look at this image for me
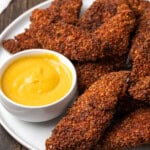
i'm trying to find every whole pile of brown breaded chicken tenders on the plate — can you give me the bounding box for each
[3,0,150,150]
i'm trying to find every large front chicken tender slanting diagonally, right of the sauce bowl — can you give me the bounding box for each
[46,71,129,150]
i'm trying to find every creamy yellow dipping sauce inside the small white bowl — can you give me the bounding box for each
[2,54,72,106]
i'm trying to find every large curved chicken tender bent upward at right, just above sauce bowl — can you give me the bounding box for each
[36,5,135,62]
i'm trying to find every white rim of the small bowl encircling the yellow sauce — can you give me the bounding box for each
[0,48,77,109]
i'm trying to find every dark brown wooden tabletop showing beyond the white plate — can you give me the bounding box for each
[0,0,44,150]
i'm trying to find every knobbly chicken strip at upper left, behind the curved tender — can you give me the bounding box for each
[3,0,82,53]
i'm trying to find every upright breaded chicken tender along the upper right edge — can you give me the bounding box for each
[130,9,150,80]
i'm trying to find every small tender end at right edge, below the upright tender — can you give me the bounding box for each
[129,76,150,104]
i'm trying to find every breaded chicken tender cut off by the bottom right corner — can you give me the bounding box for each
[95,108,150,150]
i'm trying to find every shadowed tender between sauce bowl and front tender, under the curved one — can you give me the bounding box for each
[74,55,126,94]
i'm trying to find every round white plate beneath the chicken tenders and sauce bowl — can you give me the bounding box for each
[0,0,150,150]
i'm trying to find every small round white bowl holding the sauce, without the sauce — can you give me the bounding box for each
[0,49,77,122]
